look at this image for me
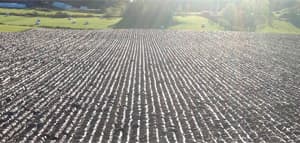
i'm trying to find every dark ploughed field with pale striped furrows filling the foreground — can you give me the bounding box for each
[0,29,300,143]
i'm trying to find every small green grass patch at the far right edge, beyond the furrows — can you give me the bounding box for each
[257,20,300,34]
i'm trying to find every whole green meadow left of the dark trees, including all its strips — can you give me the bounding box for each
[0,8,120,32]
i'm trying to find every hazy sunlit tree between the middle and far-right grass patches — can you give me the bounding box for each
[221,0,272,31]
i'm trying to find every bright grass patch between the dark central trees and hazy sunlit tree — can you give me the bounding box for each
[170,16,224,31]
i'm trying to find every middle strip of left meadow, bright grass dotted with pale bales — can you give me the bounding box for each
[0,15,120,29]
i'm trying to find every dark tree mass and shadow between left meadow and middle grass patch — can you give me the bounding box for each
[113,0,175,29]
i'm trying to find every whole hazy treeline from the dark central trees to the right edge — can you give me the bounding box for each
[112,0,300,31]
